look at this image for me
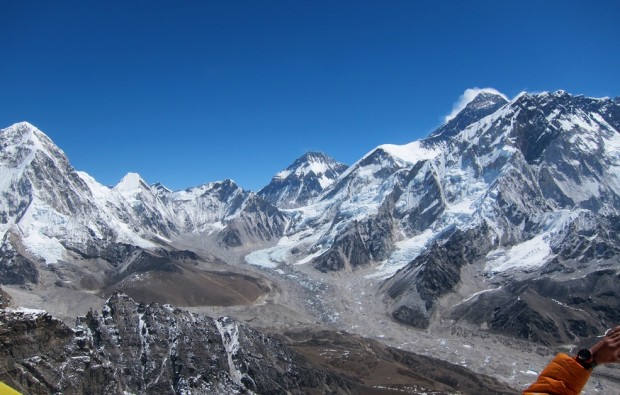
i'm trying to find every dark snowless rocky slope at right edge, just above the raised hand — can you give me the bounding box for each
[452,270,620,345]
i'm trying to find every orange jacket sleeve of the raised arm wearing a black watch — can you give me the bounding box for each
[523,354,590,395]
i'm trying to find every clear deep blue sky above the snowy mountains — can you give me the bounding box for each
[0,0,620,190]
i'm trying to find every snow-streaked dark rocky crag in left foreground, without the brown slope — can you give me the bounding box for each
[0,294,355,394]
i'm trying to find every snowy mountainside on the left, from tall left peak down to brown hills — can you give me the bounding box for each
[0,123,288,284]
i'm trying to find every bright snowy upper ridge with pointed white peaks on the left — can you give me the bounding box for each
[0,123,272,264]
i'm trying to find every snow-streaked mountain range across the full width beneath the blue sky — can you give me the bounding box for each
[0,91,620,395]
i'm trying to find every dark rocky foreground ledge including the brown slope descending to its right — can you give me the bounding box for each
[0,293,516,394]
